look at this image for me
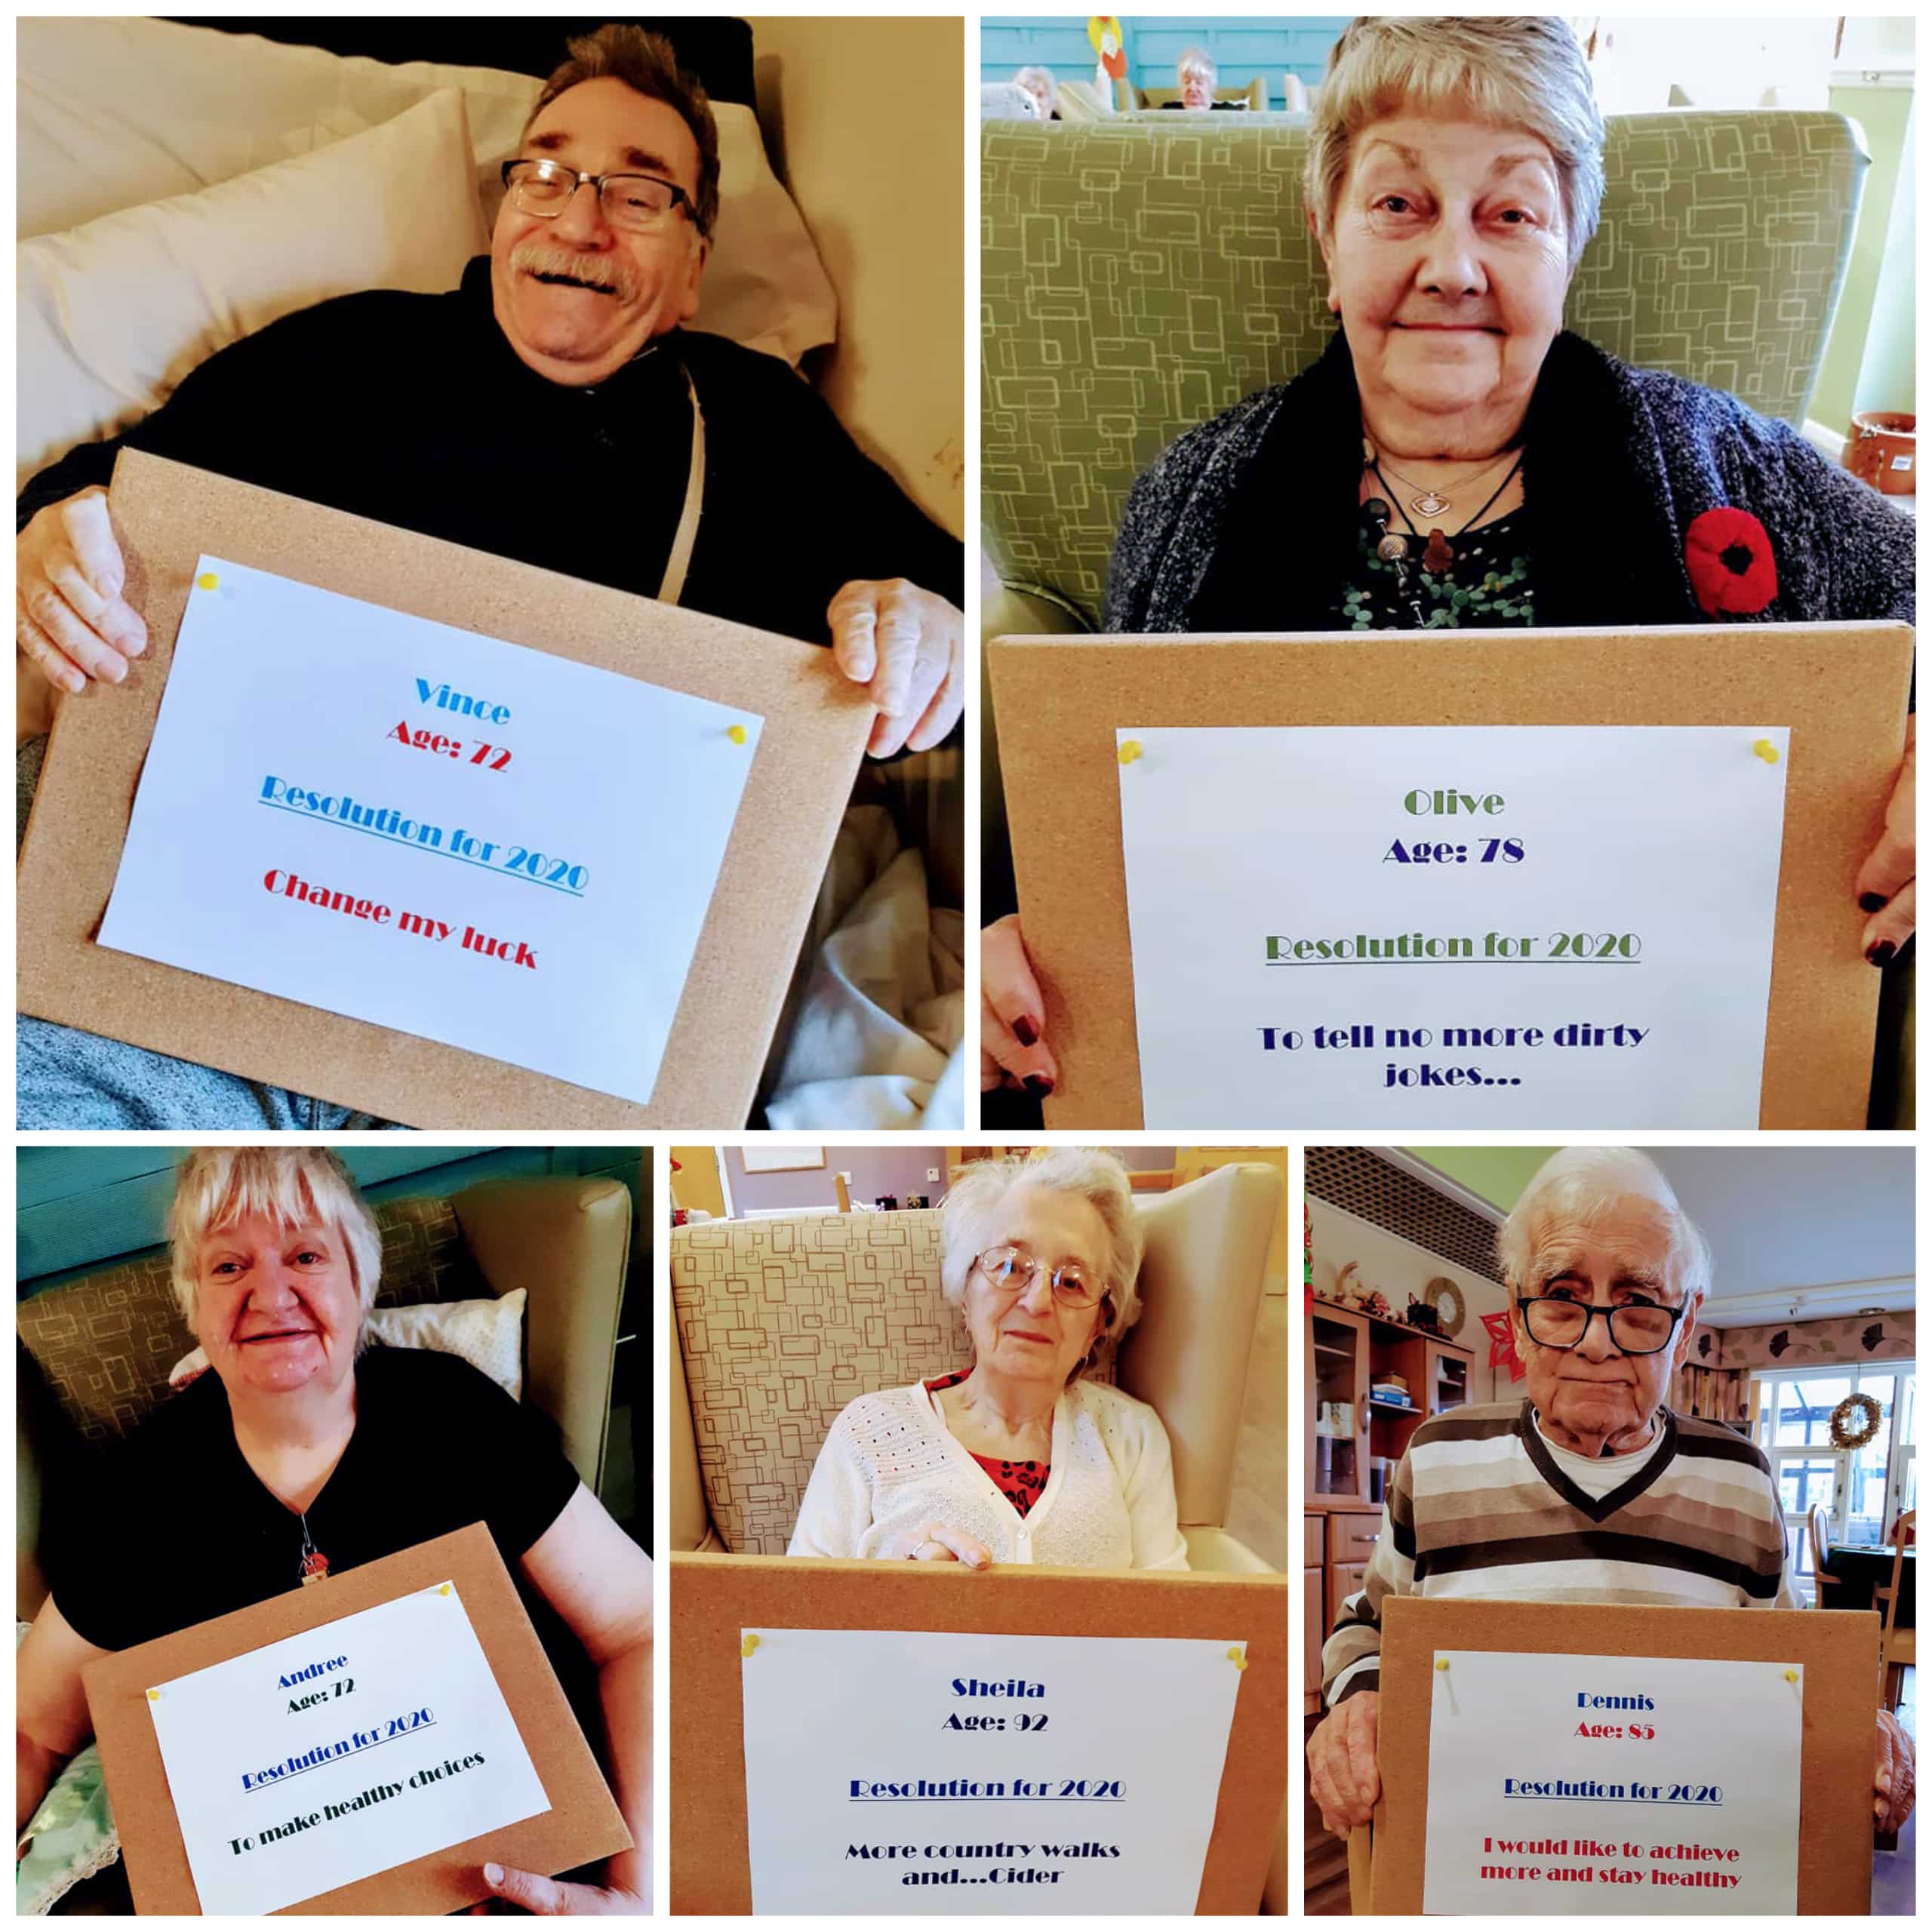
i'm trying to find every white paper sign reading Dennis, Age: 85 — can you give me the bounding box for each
[1422,1650,1804,1918]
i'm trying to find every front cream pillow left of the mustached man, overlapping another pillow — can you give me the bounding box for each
[14,89,487,489]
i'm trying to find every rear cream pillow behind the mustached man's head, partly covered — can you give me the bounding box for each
[15,20,838,369]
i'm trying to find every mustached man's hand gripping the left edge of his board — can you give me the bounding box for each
[14,489,147,726]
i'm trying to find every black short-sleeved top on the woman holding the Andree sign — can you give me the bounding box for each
[41,1349,582,1654]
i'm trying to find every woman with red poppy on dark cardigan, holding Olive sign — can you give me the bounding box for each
[980,14,1918,1096]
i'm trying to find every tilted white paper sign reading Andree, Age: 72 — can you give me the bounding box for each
[149,1584,551,1912]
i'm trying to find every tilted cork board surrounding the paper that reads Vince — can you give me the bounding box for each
[17,450,873,1128]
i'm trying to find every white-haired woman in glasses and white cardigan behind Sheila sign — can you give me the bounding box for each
[788,1148,1188,1571]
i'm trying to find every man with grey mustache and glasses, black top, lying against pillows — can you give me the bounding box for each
[15,27,966,1126]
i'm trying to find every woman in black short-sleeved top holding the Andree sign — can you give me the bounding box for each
[15,1148,651,1912]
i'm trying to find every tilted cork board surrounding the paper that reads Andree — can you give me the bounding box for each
[82,1522,632,1917]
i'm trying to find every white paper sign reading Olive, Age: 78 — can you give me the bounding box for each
[1118,724,1792,1131]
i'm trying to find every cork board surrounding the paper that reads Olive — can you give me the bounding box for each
[987,622,1912,1131]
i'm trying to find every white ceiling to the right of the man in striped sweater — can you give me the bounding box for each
[1644,1146,1917,1327]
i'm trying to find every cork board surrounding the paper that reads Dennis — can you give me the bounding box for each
[1367,1596,1878,1918]
